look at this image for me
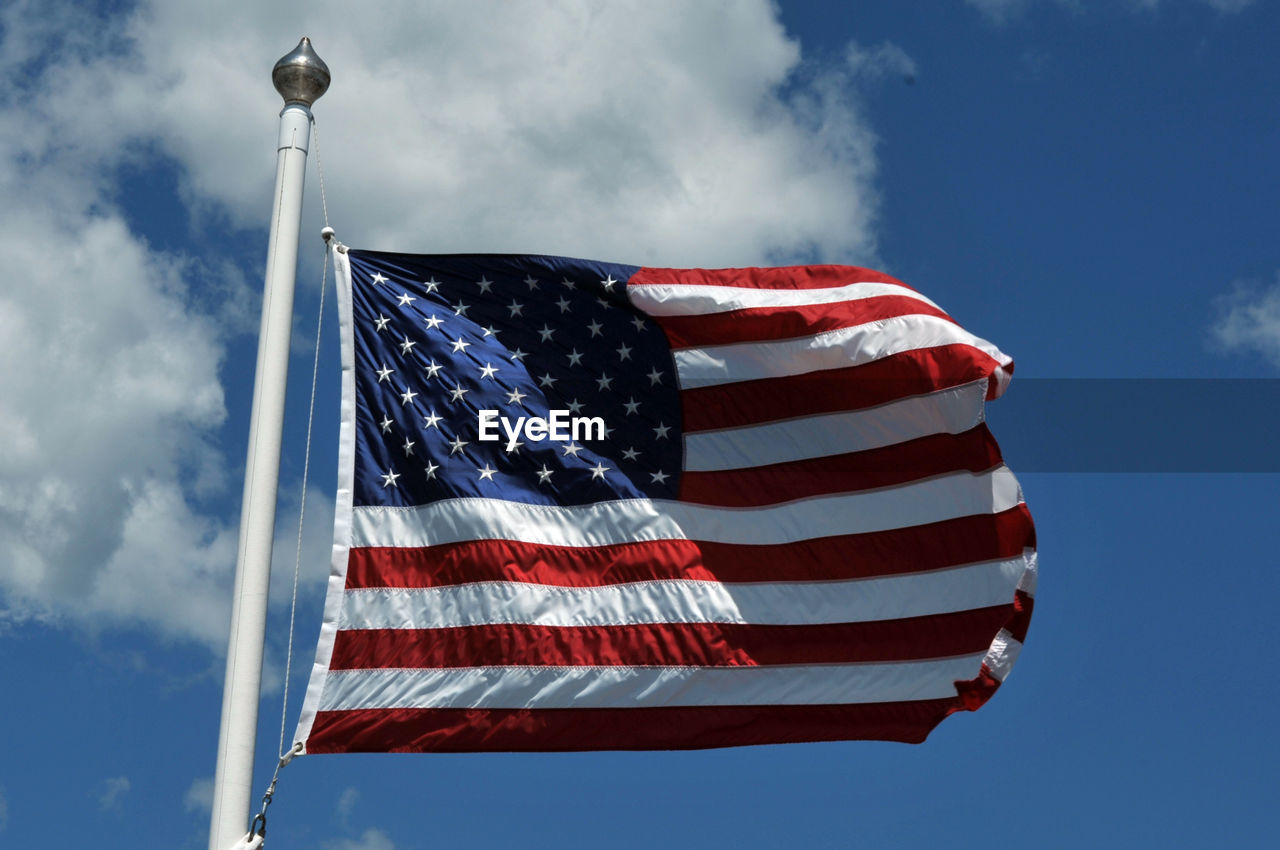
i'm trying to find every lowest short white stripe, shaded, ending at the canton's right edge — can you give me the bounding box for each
[685,379,987,472]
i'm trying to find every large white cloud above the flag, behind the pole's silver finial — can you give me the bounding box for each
[67,0,874,264]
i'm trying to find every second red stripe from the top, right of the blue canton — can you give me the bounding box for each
[654,296,955,348]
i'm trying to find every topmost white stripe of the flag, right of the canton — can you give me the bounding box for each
[627,283,941,316]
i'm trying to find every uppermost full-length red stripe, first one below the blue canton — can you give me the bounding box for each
[347,504,1034,589]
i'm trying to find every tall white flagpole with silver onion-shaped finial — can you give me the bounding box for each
[209,38,329,850]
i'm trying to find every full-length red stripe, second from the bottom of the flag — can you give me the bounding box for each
[329,604,1014,670]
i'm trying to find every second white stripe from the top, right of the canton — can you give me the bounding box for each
[672,315,1010,389]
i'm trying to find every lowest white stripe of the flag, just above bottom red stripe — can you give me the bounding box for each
[314,655,982,712]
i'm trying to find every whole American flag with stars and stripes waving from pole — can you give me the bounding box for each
[296,248,1036,753]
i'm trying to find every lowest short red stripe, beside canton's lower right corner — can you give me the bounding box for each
[680,425,1002,507]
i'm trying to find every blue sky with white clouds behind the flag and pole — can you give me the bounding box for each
[0,0,1280,850]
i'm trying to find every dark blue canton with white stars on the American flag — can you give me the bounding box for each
[348,251,682,506]
